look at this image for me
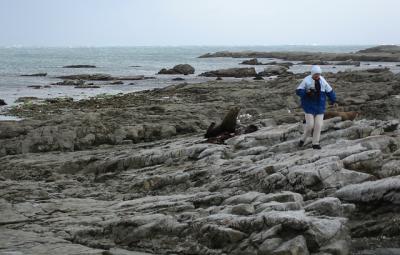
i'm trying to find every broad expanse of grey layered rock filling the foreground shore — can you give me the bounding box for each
[0,46,400,255]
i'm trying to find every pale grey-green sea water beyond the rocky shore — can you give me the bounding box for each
[0,45,396,105]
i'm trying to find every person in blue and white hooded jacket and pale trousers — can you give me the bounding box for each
[296,65,336,150]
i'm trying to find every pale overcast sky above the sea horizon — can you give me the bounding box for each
[0,0,400,46]
